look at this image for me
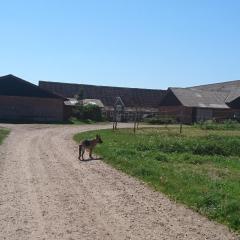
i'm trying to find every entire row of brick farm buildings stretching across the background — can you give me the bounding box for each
[0,75,240,124]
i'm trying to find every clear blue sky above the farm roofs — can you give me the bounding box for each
[0,0,240,89]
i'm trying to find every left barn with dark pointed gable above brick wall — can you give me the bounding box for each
[0,75,66,122]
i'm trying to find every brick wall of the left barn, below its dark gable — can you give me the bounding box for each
[0,96,64,122]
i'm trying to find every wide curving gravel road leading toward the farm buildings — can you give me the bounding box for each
[0,125,237,240]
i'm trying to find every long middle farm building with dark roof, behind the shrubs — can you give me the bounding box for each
[39,81,166,121]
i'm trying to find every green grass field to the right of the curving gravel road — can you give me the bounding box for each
[74,127,240,232]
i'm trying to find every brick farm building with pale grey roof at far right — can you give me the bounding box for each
[159,81,240,123]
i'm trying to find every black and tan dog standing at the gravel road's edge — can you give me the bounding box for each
[78,135,103,160]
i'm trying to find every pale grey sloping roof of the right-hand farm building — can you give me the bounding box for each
[170,88,229,108]
